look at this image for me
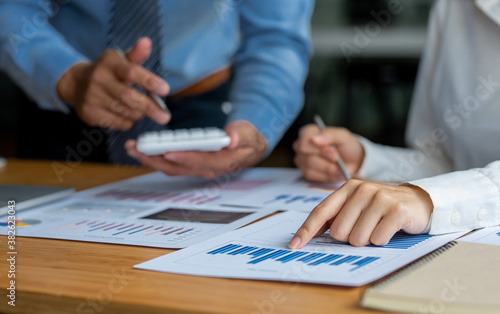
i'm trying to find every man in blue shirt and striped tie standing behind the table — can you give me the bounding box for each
[0,0,314,177]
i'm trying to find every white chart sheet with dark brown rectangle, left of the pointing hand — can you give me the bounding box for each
[0,202,272,249]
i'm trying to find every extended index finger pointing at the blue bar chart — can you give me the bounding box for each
[288,188,347,249]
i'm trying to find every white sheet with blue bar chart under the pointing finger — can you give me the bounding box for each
[135,211,463,286]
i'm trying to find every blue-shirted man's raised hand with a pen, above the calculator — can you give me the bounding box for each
[56,38,170,130]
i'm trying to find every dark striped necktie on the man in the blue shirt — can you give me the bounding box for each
[107,0,162,164]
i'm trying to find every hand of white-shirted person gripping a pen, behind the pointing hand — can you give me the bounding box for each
[293,124,365,183]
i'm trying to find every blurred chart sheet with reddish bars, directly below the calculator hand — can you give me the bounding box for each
[74,168,300,207]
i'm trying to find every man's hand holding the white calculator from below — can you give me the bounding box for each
[125,121,267,178]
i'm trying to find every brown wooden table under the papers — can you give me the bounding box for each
[0,159,379,314]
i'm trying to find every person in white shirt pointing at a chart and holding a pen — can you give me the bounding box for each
[289,0,500,248]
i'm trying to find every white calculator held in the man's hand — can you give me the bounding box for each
[137,127,231,156]
